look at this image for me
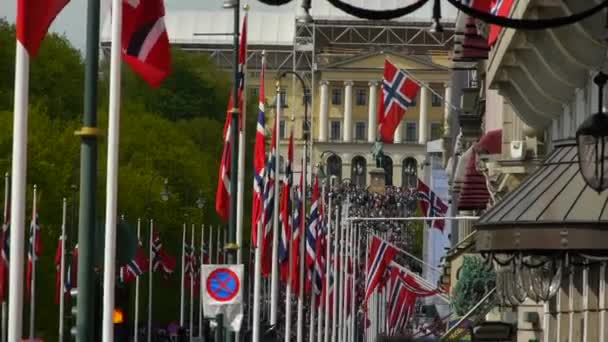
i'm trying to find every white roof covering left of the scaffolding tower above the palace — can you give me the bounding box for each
[101,11,295,46]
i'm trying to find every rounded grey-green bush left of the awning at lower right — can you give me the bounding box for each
[452,255,496,316]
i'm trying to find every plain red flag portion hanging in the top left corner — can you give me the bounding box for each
[17,0,70,57]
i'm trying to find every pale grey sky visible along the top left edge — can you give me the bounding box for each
[0,0,288,49]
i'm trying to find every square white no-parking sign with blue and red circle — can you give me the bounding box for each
[201,264,245,331]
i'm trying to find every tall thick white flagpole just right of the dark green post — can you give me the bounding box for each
[102,0,122,342]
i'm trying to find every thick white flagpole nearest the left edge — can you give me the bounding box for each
[8,26,30,342]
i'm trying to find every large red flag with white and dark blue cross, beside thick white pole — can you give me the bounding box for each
[122,0,171,88]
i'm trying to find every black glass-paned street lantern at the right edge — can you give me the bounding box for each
[576,71,608,193]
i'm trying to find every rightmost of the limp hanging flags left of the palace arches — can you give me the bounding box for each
[306,177,321,294]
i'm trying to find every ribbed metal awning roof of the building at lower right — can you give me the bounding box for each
[475,140,608,251]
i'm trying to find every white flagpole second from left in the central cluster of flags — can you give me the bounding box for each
[270,81,283,326]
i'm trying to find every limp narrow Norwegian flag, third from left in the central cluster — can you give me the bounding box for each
[279,131,293,282]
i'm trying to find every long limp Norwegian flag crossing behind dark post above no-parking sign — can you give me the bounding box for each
[215,15,247,222]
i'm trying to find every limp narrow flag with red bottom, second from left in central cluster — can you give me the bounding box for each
[262,122,277,277]
